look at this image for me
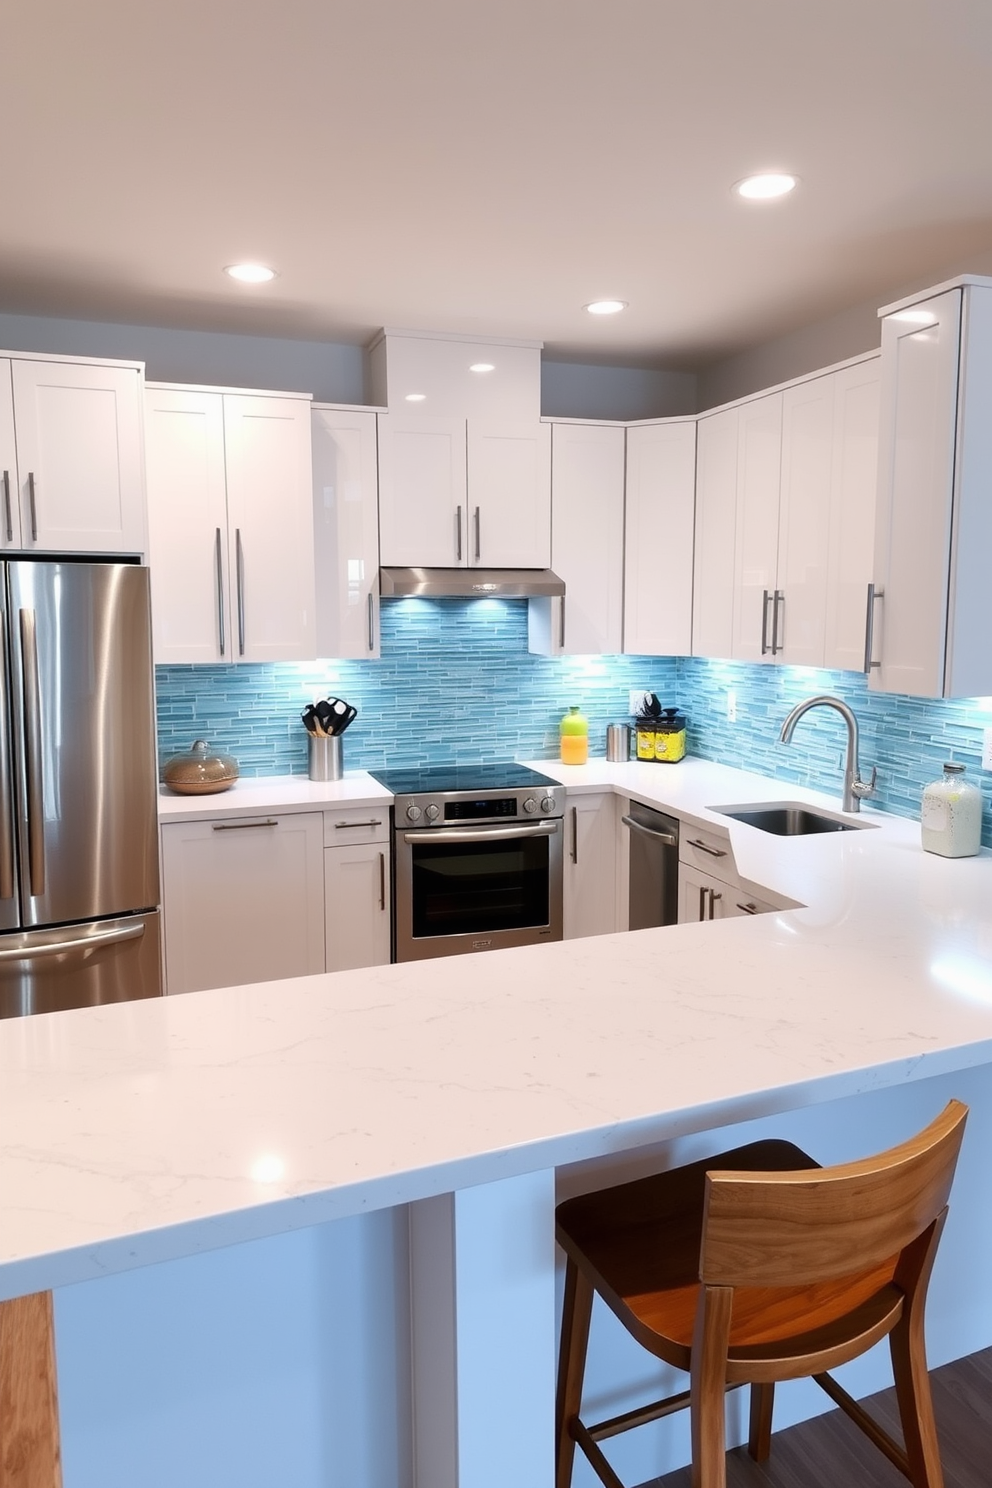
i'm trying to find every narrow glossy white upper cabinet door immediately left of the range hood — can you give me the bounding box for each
[312,406,379,661]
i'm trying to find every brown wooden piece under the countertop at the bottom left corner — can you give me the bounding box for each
[0,1292,62,1488]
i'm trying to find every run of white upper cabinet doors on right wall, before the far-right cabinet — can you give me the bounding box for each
[693,357,879,671]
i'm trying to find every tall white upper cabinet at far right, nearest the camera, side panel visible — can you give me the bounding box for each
[870,281,992,698]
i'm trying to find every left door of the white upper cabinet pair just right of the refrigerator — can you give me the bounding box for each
[144,387,233,664]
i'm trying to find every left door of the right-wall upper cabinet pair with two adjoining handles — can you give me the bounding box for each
[733,393,782,662]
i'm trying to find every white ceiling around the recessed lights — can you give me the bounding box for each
[0,0,992,368]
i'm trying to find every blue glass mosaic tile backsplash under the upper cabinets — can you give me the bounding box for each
[156,600,992,847]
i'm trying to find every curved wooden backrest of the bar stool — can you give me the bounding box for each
[699,1101,968,1287]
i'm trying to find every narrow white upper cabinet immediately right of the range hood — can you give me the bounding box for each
[528,424,623,656]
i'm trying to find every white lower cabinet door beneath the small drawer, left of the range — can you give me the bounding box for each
[324,842,390,972]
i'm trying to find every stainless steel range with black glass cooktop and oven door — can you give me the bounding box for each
[372,765,565,961]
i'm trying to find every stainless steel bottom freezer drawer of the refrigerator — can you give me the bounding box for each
[0,909,162,1018]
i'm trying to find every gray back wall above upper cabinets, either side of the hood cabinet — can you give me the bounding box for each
[0,314,696,418]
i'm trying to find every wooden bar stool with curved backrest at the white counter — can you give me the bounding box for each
[556,1101,968,1488]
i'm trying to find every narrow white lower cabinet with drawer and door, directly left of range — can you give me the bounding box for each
[324,806,390,972]
